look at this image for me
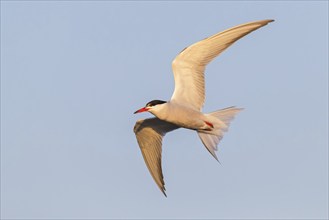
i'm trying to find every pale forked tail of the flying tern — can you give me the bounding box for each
[197,107,243,161]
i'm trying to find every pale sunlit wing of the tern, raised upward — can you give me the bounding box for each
[171,20,273,111]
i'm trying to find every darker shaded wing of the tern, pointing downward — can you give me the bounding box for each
[134,118,179,196]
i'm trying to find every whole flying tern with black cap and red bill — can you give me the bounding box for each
[134,20,274,196]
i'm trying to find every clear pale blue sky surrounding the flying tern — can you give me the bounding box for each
[1,1,328,219]
